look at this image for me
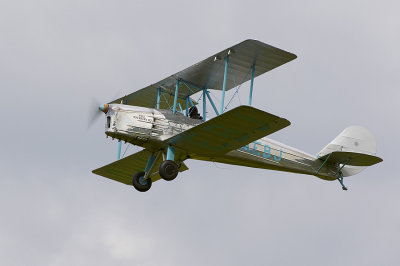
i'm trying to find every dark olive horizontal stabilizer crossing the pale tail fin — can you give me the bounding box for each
[319,151,382,166]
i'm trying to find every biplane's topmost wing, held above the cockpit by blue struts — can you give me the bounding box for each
[111,40,296,109]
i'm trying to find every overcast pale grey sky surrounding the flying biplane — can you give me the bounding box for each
[0,0,400,266]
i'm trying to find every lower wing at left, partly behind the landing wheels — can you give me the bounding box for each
[92,150,188,185]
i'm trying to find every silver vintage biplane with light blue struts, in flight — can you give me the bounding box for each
[93,40,382,192]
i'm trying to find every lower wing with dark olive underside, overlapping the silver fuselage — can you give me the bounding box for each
[166,106,290,156]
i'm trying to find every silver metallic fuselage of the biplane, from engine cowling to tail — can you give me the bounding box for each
[105,104,338,180]
